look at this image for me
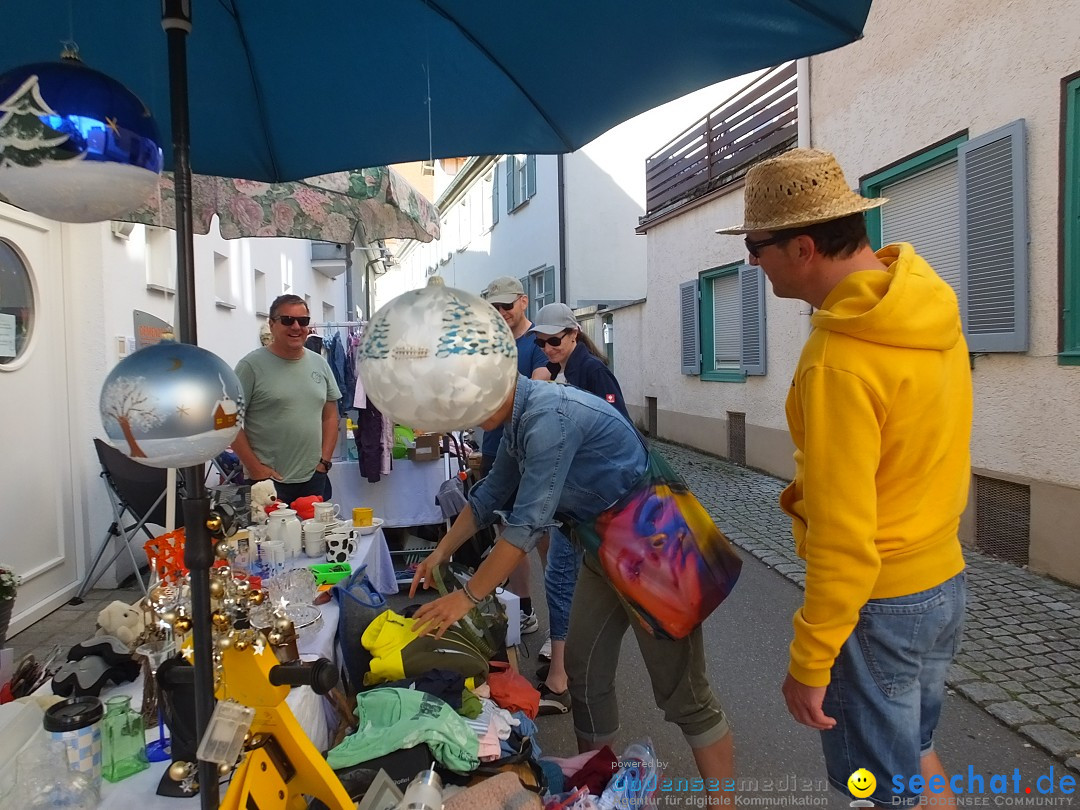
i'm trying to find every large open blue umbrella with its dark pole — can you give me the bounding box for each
[0,0,870,808]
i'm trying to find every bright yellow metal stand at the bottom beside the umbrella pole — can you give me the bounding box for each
[217,645,356,810]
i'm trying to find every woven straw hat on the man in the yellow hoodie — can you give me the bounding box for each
[716,149,889,233]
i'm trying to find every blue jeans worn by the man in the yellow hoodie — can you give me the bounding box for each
[821,572,966,807]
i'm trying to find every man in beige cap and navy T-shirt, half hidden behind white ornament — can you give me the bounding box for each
[480,275,551,633]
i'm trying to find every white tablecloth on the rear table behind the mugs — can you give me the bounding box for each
[329,456,450,527]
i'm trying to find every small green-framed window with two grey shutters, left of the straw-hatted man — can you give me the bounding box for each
[679,265,766,382]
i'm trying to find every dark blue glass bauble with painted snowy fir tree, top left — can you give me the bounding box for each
[0,49,163,222]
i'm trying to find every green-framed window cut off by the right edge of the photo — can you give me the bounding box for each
[1057,76,1080,366]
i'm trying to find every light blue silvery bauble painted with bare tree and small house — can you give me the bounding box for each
[100,340,243,467]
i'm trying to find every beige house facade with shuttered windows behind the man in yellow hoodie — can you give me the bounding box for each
[615,0,1080,583]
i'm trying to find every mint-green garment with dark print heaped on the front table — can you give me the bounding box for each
[326,687,480,773]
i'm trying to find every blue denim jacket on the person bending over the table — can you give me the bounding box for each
[469,376,648,552]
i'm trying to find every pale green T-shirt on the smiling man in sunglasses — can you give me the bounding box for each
[237,348,341,484]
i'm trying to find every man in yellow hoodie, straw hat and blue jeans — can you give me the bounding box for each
[718,149,972,806]
